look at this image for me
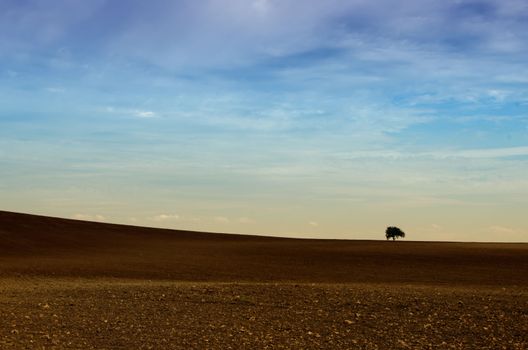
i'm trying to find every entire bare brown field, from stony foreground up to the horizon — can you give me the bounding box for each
[0,211,528,349]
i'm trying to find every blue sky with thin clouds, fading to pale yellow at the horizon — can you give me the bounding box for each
[0,0,528,242]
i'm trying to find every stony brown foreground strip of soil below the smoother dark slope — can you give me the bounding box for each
[0,278,528,349]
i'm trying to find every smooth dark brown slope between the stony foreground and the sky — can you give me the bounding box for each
[0,211,528,286]
